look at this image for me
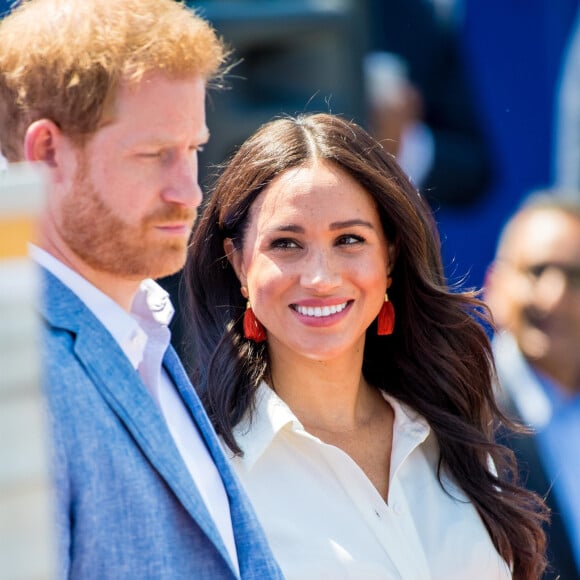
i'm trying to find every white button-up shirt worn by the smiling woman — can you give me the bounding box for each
[232,383,511,580]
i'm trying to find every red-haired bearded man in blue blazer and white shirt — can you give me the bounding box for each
[0,0,280,580]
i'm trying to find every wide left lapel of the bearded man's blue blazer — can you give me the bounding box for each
[41,273,231,566]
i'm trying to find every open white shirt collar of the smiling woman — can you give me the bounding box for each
[233,382,430,473]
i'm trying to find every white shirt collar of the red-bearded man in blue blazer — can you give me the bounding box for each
[29,244,174,369]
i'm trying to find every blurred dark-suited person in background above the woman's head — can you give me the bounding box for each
[364,0,493,209]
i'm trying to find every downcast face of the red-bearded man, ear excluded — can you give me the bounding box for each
[51,74,208,280]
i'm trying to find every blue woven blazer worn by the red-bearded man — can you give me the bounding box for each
[41,269,282,580]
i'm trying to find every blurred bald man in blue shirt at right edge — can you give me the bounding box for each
[486,195,580,580]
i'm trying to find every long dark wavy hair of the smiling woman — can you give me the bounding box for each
[183,113,546,580]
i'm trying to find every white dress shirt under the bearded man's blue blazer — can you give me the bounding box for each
[29,245,239,571]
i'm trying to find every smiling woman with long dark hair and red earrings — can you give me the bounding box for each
[185,114,544,580]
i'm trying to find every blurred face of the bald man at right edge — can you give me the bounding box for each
[487,209,580,376]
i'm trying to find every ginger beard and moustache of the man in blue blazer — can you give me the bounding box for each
[62,155,196,280]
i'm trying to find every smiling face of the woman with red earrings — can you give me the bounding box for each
[226,162,392,360]
